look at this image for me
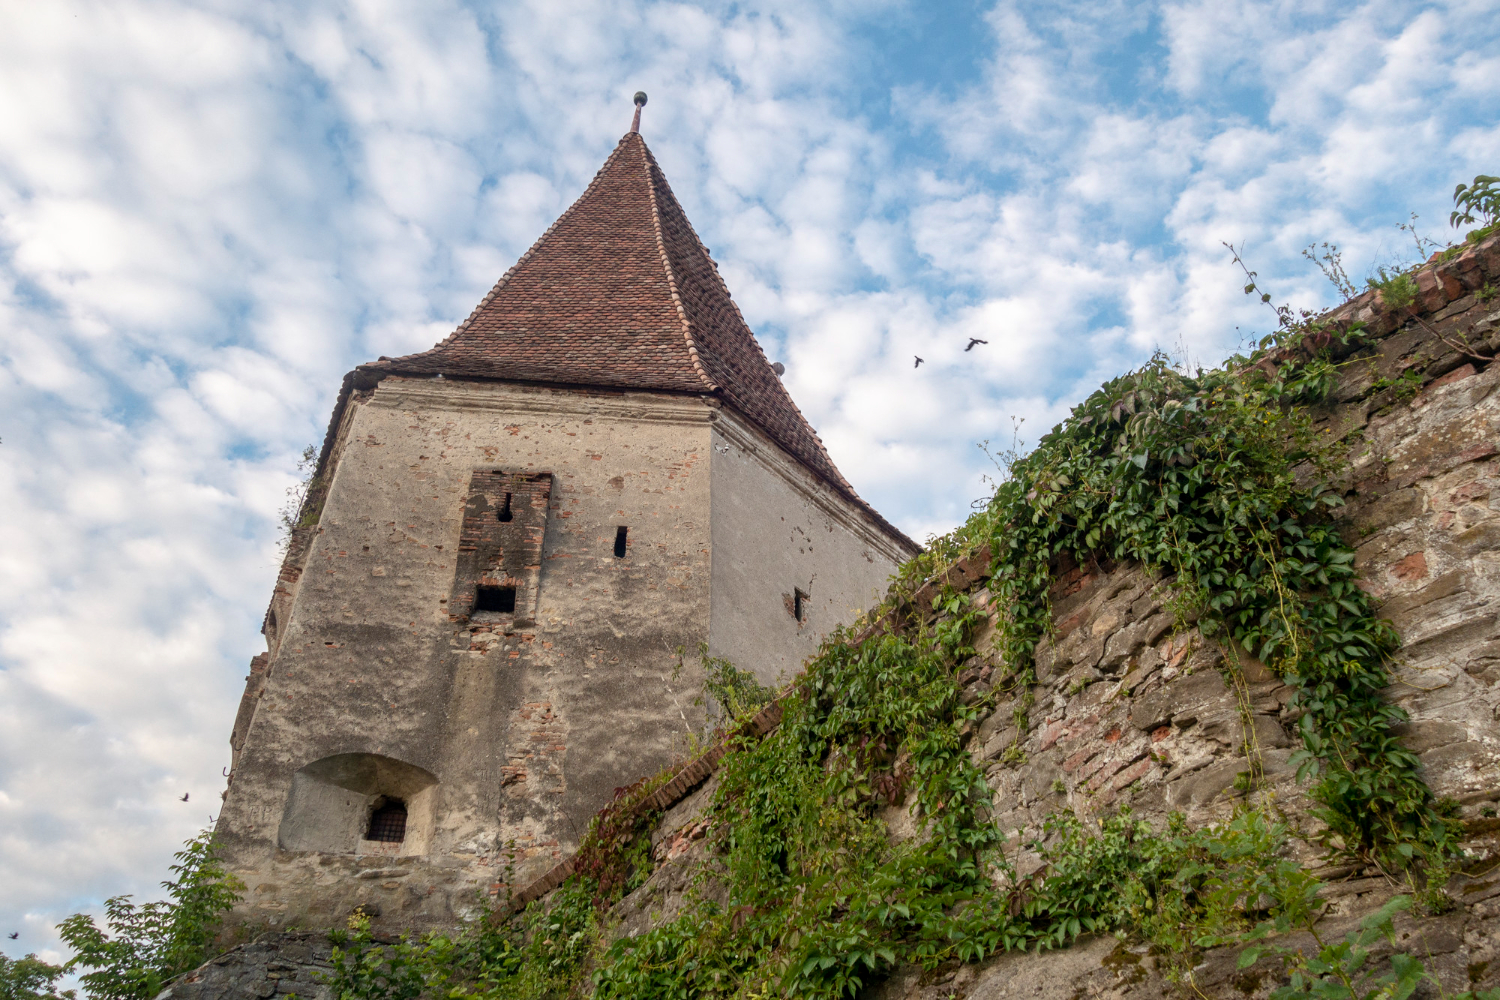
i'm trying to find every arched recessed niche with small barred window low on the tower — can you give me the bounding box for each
[276,754,438,855]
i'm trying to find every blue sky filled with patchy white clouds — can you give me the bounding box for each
[0,0,1500,957]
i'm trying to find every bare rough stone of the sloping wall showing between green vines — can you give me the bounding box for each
[185,238,1500,1000]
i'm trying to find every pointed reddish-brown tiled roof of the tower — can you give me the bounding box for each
[360,132,911,544]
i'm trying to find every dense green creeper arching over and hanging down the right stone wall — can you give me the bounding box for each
[969,331,1451,867]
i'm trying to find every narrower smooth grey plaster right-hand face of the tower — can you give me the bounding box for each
[708,411,915,684]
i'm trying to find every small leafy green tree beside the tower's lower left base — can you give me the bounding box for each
[57,831,245,1000]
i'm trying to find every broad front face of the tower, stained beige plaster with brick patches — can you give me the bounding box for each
[219,378,720,928]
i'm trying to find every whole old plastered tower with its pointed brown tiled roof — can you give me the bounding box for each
[218,121,918,928]
